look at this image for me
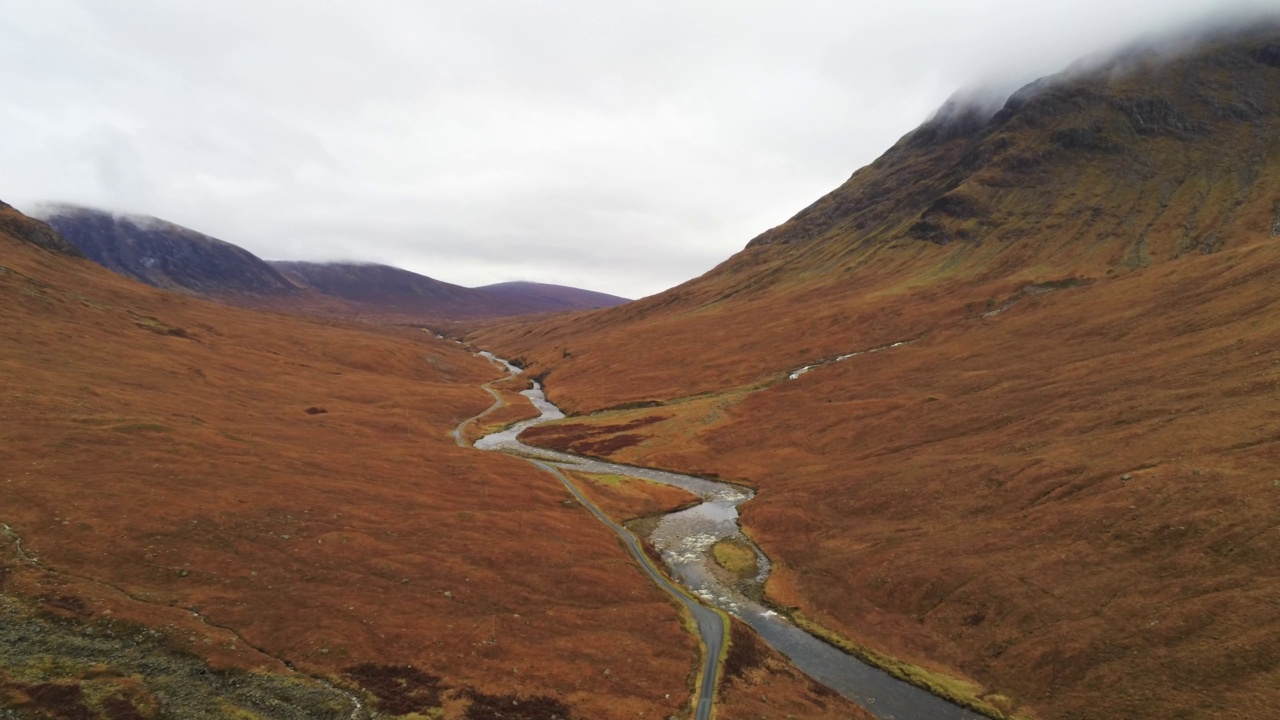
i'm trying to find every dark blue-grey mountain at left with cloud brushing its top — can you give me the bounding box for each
[37,205,297,296]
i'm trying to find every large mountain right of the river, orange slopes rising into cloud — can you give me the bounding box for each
[467,20,1280,720]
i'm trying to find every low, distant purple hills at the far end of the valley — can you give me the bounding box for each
[271,261,627,318]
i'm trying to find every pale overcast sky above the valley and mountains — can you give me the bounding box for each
[0,0,1280,297]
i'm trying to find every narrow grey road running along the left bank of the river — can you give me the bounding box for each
[451,356,728,720]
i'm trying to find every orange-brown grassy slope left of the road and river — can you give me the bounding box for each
[0,210,698,719]
